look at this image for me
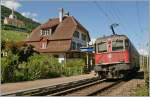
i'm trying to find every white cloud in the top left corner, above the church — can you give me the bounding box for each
[1,0,22,10]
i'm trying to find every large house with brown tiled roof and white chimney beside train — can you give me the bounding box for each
[26,9,90,63]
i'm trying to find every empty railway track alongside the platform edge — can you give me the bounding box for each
[1,77,102,96]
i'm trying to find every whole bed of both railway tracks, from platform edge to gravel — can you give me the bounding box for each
[1,71,139,96]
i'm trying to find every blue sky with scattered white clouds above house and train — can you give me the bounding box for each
[2,0,149,54]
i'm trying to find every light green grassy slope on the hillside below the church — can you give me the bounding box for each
[1,30,28,42]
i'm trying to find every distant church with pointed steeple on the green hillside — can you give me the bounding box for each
[4,9,25,27]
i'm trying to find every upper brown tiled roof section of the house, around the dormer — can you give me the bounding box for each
[27,16,90,41]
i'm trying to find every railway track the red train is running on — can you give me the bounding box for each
[52,80,122,96]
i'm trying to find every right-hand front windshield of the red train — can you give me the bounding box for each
[112,40,124,51]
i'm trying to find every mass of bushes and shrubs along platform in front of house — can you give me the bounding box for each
[1,41,85,82]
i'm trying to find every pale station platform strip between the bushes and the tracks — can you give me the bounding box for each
[1,73,95,94]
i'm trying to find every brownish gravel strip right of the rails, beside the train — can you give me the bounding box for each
[98,72,144,96]
